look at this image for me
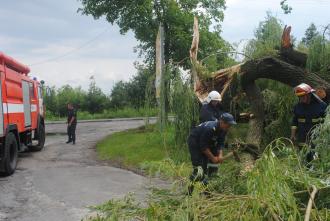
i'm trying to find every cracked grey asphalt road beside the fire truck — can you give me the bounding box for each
[0,120,156,221]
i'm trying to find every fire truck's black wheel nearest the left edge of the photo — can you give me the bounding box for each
[2,132,18,176]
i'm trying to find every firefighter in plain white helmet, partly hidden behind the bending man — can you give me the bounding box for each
[199,91,224,123]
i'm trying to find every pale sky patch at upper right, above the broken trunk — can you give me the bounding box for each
[222,0,330,42]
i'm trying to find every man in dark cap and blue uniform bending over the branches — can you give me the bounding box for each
[188,113,236,194]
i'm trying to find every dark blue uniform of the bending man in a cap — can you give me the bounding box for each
[188,121,227,181]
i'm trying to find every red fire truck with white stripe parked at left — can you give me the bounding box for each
[0,52,45,175]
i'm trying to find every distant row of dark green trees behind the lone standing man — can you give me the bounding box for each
[44,66,156,116]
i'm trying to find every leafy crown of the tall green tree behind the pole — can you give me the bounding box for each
[80,0,229,67]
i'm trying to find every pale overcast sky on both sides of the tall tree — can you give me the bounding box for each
[0,0,330,93]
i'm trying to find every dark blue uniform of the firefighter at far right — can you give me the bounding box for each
[292,96,327,145]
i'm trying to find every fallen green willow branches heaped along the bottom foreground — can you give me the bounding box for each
[87,140,329,221]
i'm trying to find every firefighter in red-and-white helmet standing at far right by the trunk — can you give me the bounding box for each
[291,83,327,162]
